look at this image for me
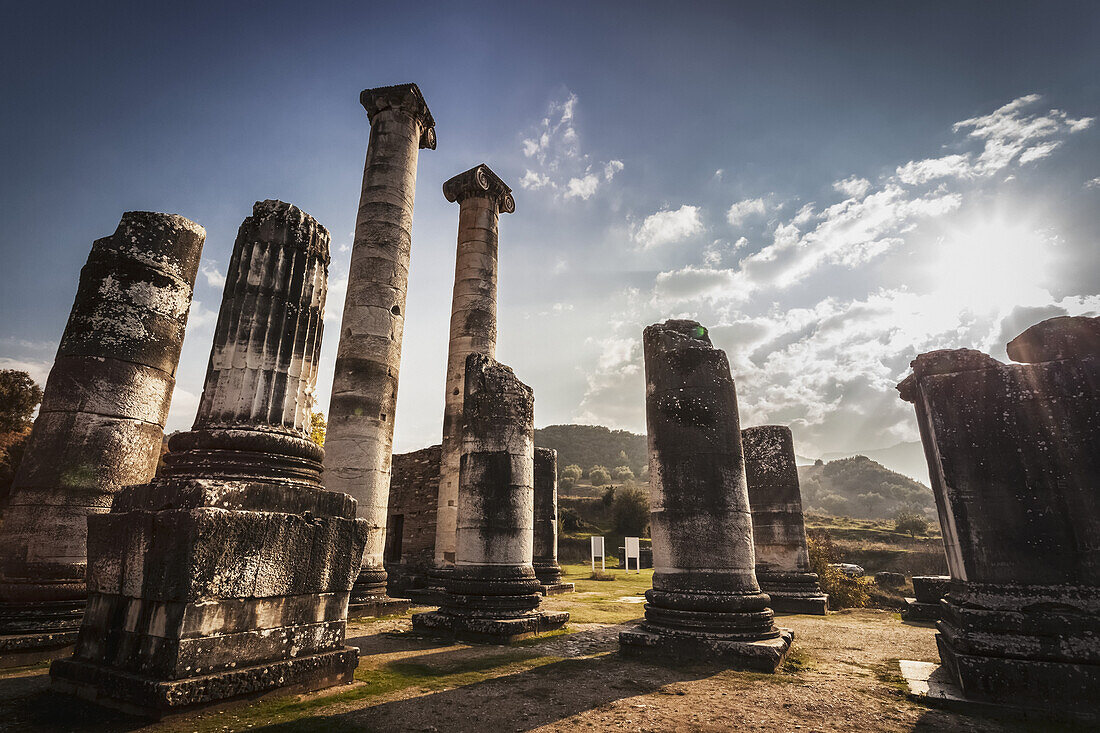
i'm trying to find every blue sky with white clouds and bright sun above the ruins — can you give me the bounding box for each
[0,2,1100,456]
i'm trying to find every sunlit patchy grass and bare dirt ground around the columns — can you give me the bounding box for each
[0,565,1062,733]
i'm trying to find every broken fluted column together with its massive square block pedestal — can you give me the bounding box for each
[51,200,366,716]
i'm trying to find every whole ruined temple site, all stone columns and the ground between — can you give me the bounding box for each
[0,75,1100,731]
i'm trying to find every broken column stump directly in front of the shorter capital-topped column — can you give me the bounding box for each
[413,353,569,643]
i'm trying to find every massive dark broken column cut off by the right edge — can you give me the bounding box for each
[899,318,1100,715]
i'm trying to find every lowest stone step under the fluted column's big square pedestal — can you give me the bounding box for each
[50,646,359,719]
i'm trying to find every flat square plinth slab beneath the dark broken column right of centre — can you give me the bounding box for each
[619,624,794,674]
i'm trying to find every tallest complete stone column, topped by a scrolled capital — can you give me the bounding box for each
[325,84,436,612]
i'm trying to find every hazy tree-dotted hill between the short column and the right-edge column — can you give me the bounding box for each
[799,456,935,519]
